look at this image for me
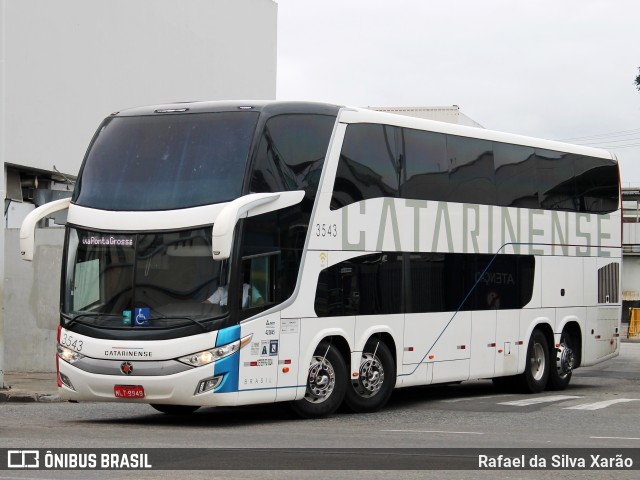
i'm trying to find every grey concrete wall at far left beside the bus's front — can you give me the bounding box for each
[4,228,64,372]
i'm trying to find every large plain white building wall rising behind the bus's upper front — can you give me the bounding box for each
[0,0,277,175]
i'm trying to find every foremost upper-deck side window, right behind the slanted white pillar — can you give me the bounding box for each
[331,124,399,210]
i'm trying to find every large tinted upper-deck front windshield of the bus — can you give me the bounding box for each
[73,112,259,211]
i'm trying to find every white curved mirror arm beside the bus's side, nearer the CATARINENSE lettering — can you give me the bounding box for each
[211,190,304,260]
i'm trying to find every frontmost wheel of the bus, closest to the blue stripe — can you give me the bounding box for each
[291,342,347,418]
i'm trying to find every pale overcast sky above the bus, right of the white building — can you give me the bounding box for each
[276,0,640,186]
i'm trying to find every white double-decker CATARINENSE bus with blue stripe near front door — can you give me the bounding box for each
[21,102,621,417]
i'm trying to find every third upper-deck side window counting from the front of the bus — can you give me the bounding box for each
[447,135,496,205]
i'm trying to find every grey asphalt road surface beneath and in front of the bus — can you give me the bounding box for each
[0,343,640,479]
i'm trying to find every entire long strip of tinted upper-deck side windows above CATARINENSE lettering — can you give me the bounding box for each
[331,124,619,213]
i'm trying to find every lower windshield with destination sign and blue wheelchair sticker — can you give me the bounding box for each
[63,227,229,328]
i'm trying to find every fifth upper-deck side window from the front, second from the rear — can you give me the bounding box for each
[536,149,577,211]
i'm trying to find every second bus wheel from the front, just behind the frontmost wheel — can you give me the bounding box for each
[344,339,396,413]
